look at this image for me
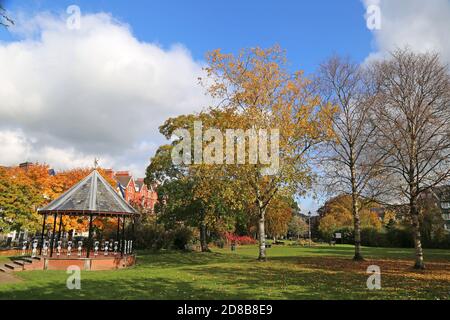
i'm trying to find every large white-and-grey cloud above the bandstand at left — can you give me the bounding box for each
[0,13,208,175]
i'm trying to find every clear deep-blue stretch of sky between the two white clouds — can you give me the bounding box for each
[0,0,373,73]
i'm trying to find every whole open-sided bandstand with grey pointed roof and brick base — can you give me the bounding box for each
[22,170,139,270]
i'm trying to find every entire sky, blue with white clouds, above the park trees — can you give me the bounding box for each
[0,0,450,215]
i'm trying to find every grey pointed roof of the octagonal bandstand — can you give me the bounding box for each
[38,170,138,215]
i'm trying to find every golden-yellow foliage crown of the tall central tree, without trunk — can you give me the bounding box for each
[177,45,338,221]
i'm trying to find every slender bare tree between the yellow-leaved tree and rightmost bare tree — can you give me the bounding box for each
[316,56,382,261]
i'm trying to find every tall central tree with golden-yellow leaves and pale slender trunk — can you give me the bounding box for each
[206,46,331,260]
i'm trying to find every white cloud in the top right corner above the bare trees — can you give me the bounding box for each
[363,0,450,63]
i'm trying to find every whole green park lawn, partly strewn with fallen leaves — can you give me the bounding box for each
[0,246,450,300]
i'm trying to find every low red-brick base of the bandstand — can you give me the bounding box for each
[24,254,136,271]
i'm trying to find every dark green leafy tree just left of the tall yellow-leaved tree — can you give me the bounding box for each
[146,113,243,252]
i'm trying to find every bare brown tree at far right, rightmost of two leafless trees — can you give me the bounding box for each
[373,49,450,269]
